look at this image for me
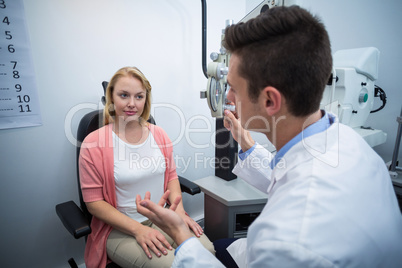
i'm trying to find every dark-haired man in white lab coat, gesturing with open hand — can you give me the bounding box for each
[137,6,402,267]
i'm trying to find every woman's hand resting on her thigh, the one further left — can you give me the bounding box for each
[135,225,173,259]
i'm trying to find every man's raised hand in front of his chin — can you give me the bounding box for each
[223,110,255,152]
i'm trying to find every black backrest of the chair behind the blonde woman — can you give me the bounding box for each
[76,81,156,223]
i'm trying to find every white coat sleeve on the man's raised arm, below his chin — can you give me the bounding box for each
[232,143,273,193]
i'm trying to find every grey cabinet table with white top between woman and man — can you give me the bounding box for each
[194,176,268,241]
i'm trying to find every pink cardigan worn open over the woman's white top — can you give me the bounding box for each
[79,124,178,268]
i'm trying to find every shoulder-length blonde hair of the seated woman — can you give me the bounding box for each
[103,67,152,125]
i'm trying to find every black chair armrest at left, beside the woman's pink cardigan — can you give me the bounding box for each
[56,201,91,239]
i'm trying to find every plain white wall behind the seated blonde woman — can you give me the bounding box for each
[0,0,245,268]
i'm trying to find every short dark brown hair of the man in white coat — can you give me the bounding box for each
[223,6,332,116]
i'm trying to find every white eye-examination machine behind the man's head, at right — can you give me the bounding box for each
[320,47,387,147]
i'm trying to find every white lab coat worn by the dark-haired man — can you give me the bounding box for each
[173,120,402,267]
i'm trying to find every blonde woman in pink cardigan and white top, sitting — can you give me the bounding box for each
[79,67,214,268]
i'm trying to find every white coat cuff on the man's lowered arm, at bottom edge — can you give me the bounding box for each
[172,239,225,268]
